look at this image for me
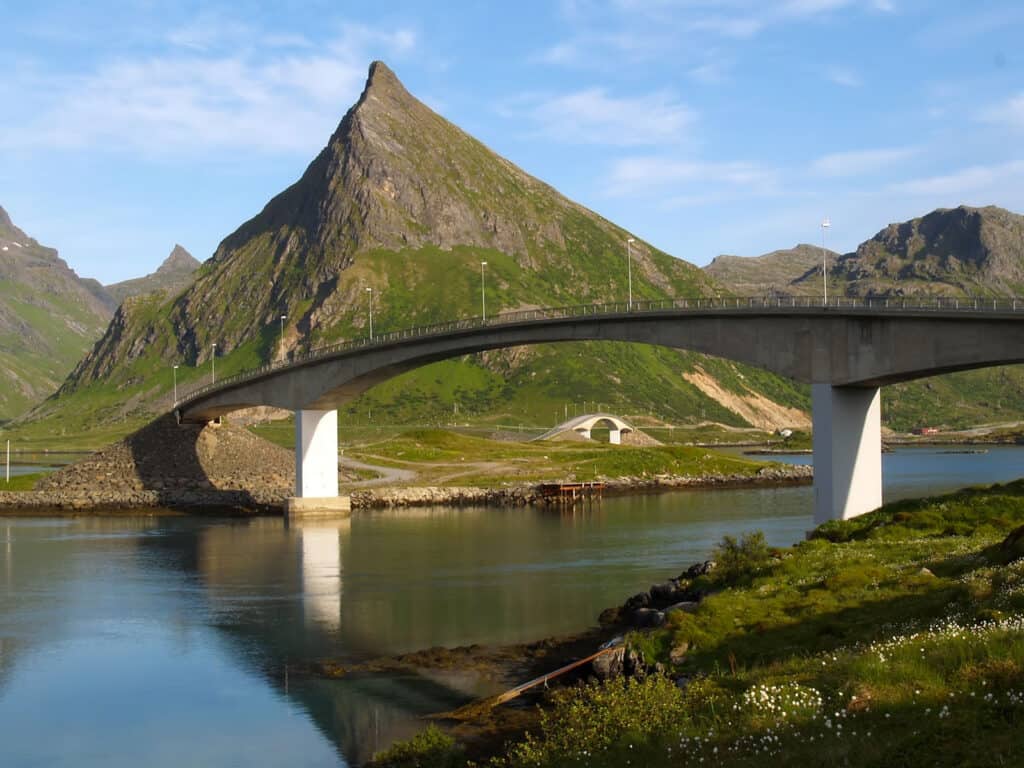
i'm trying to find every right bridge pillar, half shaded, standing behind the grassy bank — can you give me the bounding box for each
[811,384,882,525]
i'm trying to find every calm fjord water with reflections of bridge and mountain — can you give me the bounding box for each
[0,447,1024,766]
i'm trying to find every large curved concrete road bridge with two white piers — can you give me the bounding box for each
[175,297,1024,522]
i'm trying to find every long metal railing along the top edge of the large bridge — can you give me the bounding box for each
[174,295,1024,408]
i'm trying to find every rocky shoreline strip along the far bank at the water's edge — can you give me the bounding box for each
[0,466,813,515]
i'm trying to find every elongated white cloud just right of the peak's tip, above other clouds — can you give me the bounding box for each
[499,88,696,146]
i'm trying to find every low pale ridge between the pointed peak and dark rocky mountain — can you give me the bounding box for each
[705,244,840,296]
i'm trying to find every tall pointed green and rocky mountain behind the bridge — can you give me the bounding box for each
[28,62,819,436]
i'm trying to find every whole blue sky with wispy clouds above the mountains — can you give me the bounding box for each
[0,0,1024,283]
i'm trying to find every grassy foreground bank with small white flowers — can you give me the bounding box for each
[378,480,1024,768]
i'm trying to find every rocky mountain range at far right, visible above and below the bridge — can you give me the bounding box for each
[705,206,1024,429]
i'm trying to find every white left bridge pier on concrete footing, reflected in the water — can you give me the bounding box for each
[285,411,351,519]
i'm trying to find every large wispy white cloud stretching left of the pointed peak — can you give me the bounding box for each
[0,24,416,155]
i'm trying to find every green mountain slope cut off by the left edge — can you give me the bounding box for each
[0,208,113,421]
